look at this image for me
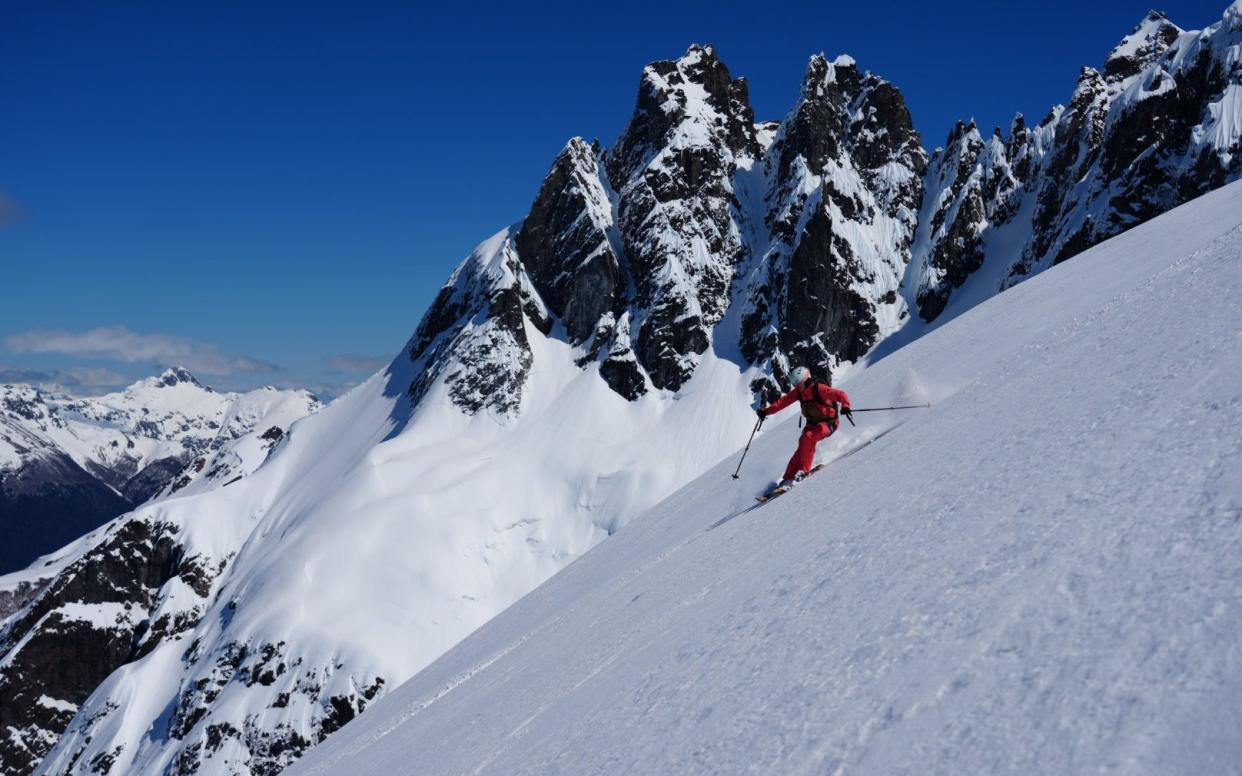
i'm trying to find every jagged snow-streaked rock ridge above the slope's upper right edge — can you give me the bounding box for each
[907,1,1242,320]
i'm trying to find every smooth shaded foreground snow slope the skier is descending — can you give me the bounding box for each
[288,184,1242,776]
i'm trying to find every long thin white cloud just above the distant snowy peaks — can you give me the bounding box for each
[5,327,279,375]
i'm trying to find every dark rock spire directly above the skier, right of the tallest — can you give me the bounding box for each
[741,56,927,377]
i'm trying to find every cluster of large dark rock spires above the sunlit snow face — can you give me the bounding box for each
[410,46,927,412]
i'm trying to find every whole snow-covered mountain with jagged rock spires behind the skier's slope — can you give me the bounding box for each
[0,0,1242,775]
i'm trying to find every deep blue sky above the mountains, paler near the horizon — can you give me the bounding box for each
[0,0,1227,392]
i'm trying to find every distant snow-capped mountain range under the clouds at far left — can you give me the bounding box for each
[0,368,319,576]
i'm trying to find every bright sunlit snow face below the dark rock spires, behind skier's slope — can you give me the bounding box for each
[26,329,754,774]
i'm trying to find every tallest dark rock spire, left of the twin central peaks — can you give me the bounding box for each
[607,46,759,391]
